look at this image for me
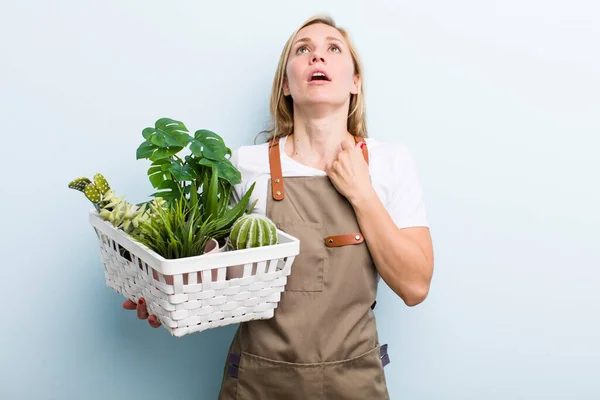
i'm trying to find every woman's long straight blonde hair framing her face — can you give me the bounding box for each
[259,15,367,141]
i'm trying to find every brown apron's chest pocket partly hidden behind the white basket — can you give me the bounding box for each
[277,222,327,292]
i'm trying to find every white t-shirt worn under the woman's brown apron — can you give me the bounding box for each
[231,137,428,228]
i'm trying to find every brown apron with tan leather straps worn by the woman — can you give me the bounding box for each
[219,138,389,400]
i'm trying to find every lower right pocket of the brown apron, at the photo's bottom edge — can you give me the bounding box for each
[323,345,390,400]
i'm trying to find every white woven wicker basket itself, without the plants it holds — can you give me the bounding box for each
[89,210,300,337]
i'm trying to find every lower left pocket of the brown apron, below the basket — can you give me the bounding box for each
[237,353,323,400]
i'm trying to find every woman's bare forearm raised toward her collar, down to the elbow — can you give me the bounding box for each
[351,190,433,306]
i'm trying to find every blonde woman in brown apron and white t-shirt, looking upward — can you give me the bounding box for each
[129,17,433,400]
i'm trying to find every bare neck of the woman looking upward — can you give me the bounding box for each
[285,104,354,170]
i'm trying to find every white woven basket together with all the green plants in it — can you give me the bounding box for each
[69,118,300,337]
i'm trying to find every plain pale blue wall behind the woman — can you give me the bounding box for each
[0,0,600,400]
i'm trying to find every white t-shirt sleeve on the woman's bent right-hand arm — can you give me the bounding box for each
[388,145,428,228]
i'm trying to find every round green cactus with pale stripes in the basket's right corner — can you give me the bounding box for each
[229,214,277,250]
